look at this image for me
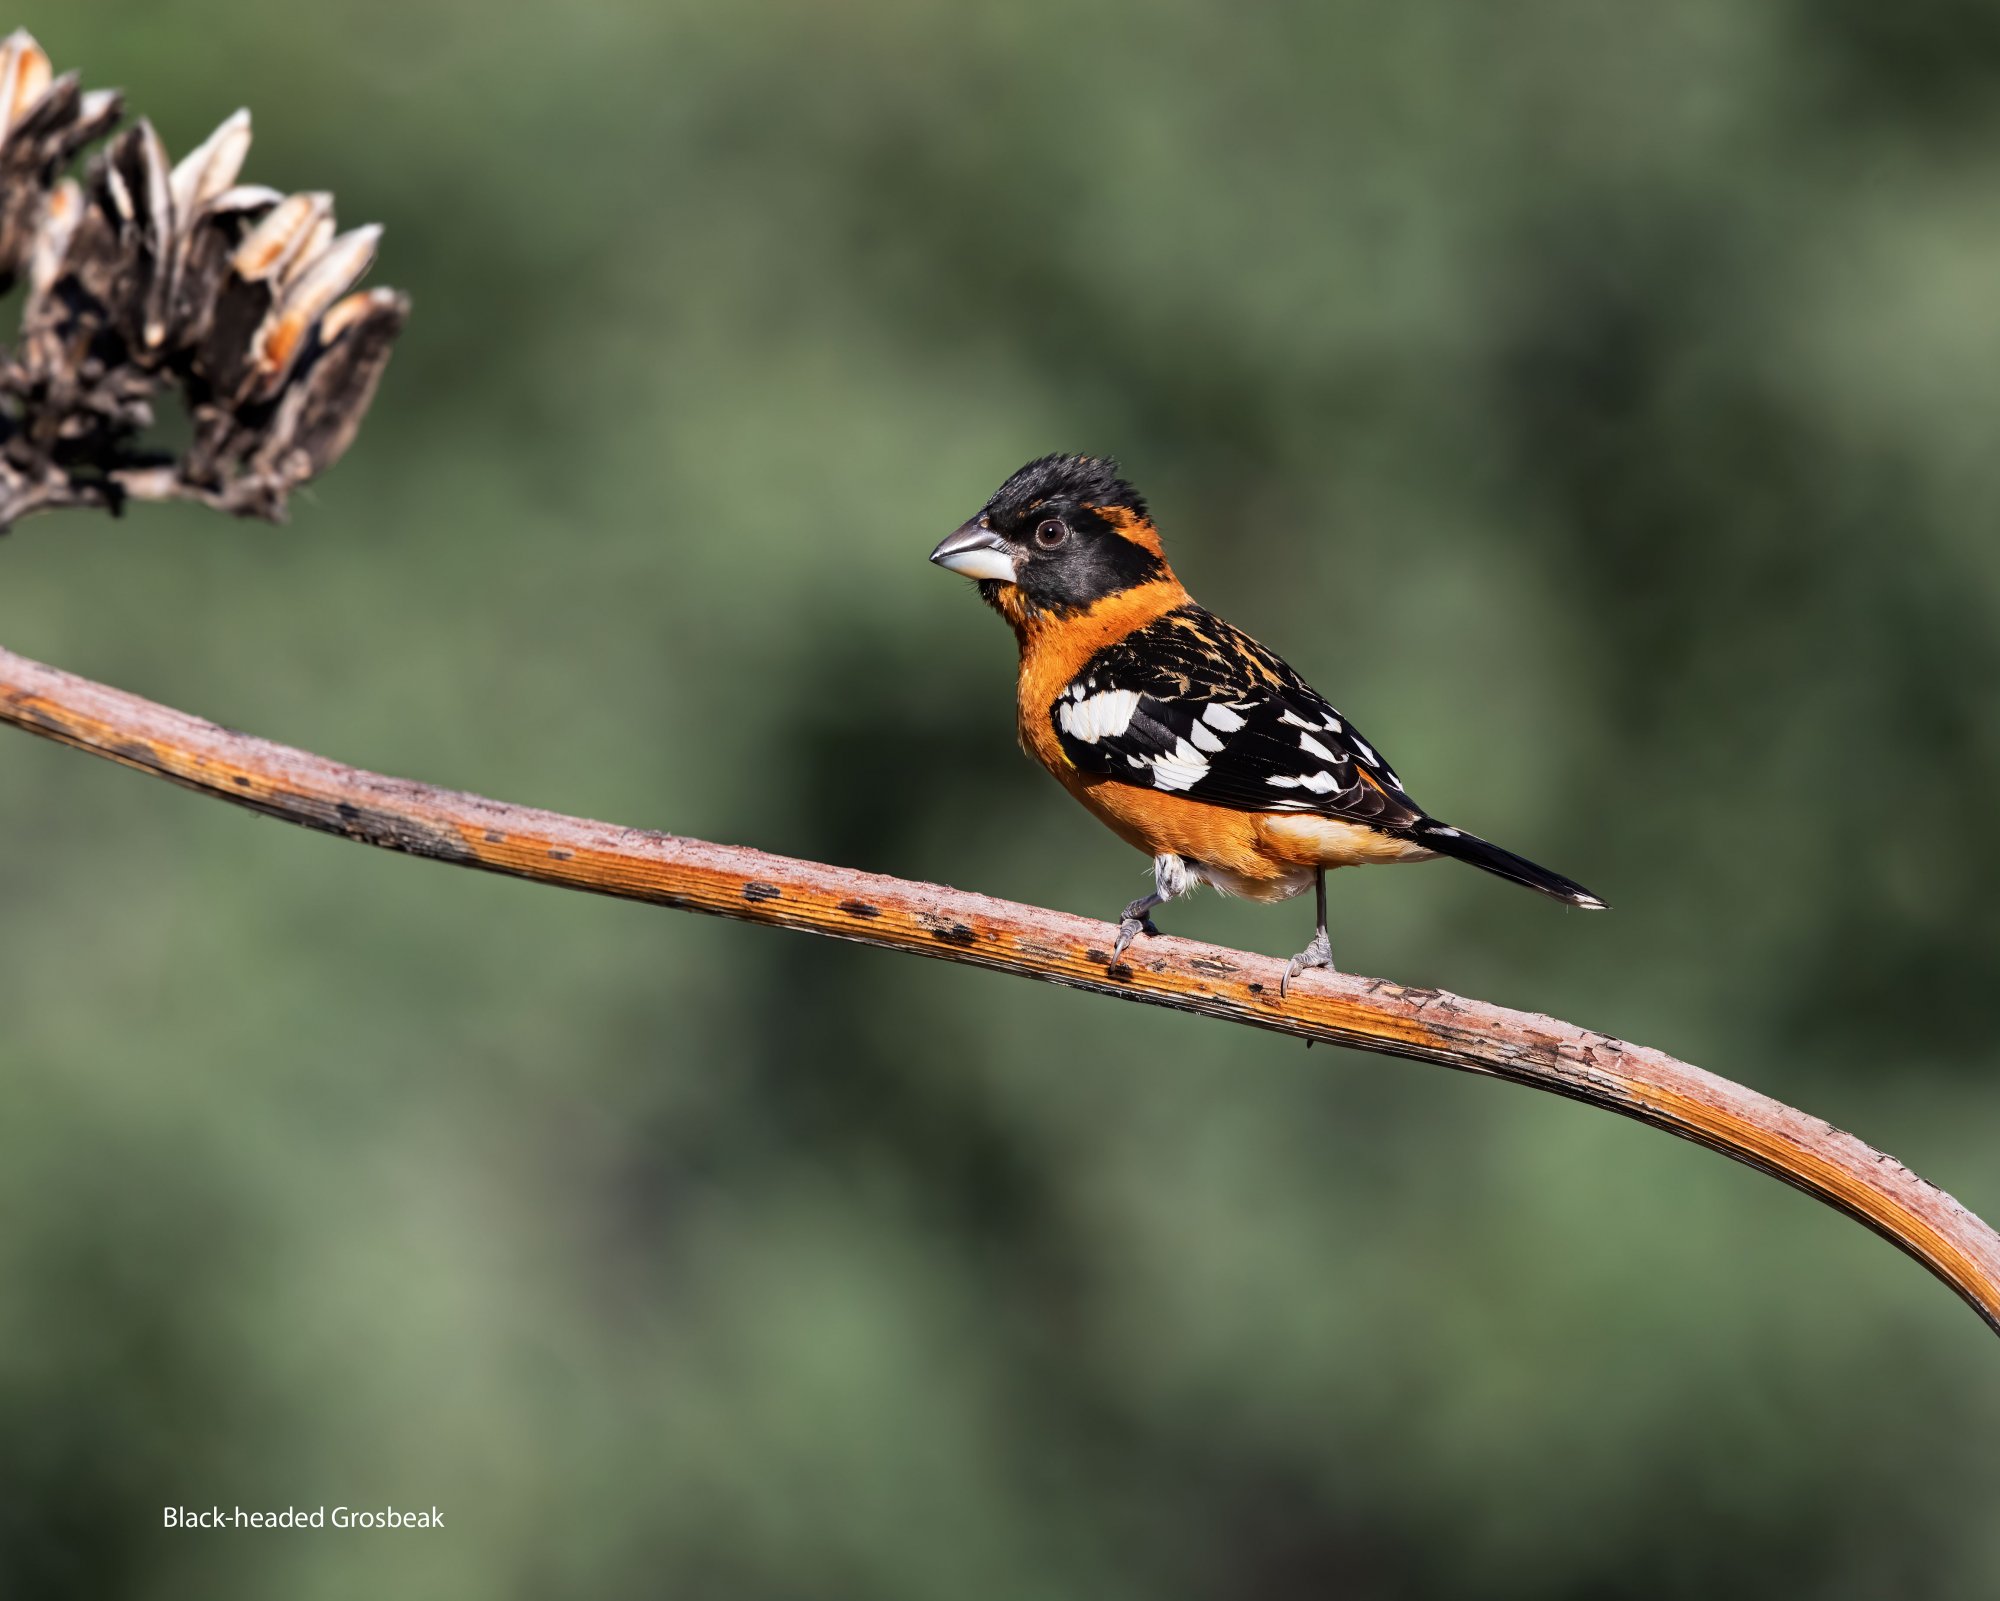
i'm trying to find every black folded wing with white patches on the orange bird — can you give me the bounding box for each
[1048,606,1424,833]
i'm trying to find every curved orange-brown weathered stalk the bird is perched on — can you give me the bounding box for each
[0,650,2000,1333]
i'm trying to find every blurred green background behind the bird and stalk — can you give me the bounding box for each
[0,0,2000,1601]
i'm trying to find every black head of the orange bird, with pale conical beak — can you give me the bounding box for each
[930,456,1168,620]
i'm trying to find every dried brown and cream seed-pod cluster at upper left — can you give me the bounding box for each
[0,32,410,530]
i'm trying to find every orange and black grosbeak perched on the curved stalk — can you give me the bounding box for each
[930,454,1606,997]
